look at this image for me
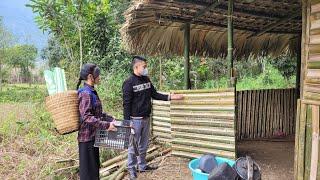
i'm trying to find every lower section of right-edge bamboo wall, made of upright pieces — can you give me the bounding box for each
[294,100,320,180]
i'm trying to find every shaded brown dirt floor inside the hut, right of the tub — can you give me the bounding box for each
[238,138,294,180]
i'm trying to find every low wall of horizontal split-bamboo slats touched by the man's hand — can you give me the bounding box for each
[152,89,236,159]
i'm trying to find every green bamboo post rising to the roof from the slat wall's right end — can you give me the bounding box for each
[227,0,235,86]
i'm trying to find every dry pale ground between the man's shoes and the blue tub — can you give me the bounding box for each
[124,154,192,180]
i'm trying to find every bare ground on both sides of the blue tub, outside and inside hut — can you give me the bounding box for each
[124,138,294,180]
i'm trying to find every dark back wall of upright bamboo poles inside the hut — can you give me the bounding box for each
[237,89,296,140]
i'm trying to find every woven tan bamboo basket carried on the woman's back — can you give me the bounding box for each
[46,91,79,134]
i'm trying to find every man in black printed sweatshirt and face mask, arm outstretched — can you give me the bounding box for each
[122,56,183,179]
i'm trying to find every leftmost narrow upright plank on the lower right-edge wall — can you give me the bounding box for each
[297,102,307,180]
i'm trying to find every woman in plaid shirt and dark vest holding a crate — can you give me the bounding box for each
[77,63,117,180]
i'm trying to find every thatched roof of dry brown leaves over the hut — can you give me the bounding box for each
[121,0,301,57]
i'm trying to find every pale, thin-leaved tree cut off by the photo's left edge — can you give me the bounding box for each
[0,16,13,91]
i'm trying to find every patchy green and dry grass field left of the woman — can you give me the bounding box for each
[0,84,116,179]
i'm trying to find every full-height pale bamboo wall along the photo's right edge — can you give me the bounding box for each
[294,0,320,180]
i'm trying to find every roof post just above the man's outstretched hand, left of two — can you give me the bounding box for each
[184,23,191,89]
